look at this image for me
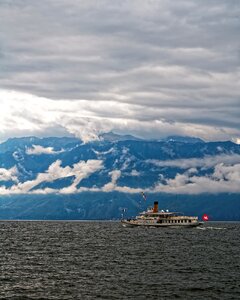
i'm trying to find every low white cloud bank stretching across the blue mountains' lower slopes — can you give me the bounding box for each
[0,155,240,195]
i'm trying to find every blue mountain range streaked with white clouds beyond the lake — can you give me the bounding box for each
[0,133,240,219]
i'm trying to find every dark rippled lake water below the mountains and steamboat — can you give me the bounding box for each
[0,221,240,299]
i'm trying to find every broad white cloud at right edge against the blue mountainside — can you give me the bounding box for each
[147,154,240,194]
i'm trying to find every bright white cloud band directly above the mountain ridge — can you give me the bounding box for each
[0,90,240,144]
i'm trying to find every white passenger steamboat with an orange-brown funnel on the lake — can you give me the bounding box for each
[121,201,203,227]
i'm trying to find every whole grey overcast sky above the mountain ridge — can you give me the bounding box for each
[0,0,240,142]
